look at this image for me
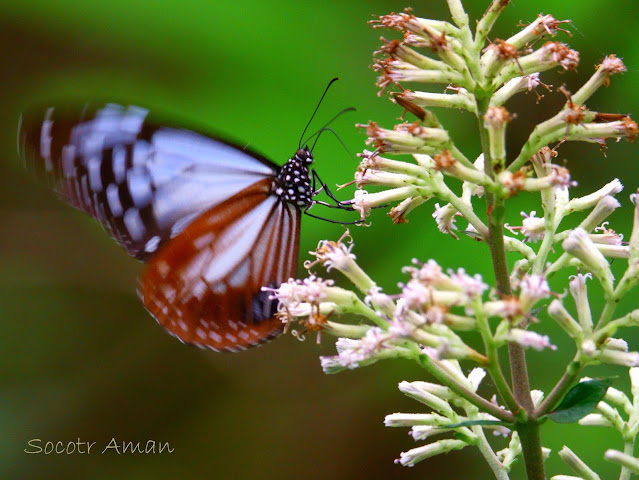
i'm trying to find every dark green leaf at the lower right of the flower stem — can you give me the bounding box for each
[545,378,613,423]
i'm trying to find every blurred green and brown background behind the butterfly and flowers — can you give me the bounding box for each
[0,0,639,480]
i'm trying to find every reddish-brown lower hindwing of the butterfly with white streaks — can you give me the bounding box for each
[138,180,300,351]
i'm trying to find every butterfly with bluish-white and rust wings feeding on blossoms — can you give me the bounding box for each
[18,80,356,352]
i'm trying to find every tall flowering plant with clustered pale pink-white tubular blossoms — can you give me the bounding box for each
[271,0,639,480]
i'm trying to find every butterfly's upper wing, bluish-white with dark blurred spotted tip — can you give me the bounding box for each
[18,104,278,259]
